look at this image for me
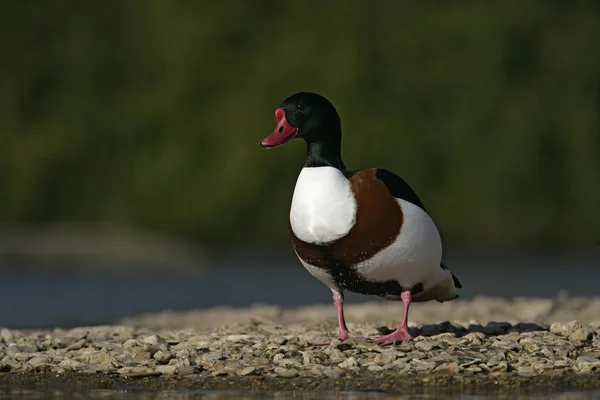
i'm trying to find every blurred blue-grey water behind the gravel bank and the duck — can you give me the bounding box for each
[0,254,600,328]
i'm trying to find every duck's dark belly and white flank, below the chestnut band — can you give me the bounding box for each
[292,199,444,297]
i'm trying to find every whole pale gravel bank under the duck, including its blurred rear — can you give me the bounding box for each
[0,298,600,390]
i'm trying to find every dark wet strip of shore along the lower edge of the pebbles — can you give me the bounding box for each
[0,372,600,396]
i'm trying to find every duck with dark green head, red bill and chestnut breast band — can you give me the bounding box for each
[259,92,462,345]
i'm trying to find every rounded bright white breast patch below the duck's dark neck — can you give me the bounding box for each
[290,167,356,244]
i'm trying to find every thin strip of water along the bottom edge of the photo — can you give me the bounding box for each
[0,390,600,400]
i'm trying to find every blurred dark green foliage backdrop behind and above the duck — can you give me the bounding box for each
[0,0,600,255]
